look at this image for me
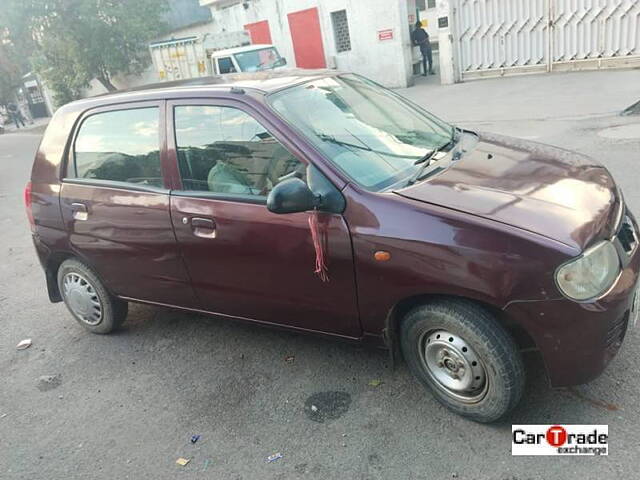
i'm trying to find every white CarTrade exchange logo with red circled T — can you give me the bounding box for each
[511,425,609,455]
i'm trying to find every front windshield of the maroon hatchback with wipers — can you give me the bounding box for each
[270,75,454,191]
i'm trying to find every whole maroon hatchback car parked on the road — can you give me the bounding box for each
[25,71,640,422]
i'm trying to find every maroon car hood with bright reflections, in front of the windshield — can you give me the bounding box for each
[395,133,619,250]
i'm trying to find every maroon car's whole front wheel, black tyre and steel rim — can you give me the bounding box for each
[400,299,525,423]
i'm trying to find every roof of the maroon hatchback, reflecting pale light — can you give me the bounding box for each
[69,69,345,105]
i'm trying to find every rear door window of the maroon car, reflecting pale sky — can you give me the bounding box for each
[67,107,163,187]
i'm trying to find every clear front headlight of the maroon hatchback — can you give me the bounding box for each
[556,241,620,300]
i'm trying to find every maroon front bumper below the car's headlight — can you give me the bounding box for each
[505,214,640,387]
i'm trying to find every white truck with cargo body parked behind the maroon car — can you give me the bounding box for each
[149,32,287,81]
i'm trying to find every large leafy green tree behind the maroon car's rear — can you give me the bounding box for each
[0,0,167,103]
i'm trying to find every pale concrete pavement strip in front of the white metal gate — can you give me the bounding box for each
[398,69,640,124]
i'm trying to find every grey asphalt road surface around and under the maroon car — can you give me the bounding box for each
[0,72,640,480]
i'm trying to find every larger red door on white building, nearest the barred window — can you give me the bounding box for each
[287,8,327,68]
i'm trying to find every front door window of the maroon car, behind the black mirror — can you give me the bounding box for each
[174,105,306,199]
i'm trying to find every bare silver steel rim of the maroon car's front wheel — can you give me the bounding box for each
[419,330,489,403]
